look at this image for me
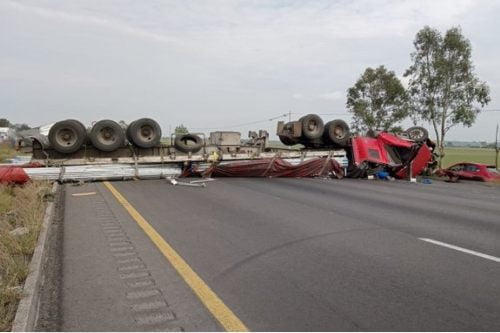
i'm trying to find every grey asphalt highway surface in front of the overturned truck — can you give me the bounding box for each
[55,179,500,331]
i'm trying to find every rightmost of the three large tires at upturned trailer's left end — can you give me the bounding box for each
[127,118,161,148]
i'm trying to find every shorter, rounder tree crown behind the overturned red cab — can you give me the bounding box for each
[347,66,408,133]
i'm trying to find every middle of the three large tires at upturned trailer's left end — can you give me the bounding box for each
[89,120,125,152]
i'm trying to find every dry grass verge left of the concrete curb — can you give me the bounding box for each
[0,182,51,331]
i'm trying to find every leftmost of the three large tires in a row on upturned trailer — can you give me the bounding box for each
[49,119,87,154]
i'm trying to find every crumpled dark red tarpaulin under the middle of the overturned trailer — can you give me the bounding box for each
[183,157,344,178]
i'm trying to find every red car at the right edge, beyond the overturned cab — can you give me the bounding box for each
[443,162,500,182]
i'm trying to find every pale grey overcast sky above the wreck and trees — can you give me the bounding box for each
[0,0,500,141]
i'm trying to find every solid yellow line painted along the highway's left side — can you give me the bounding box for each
[104,182,248,332]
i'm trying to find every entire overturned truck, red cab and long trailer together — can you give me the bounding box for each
[0,114,432,182]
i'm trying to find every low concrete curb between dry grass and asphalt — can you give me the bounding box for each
[12,183,59,332]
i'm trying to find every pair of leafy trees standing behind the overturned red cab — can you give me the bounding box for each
[346,26,491,165]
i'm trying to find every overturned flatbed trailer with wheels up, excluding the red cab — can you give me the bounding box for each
[0,118,348,181]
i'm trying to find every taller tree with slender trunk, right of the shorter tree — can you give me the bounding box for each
[405,26,490,167]
